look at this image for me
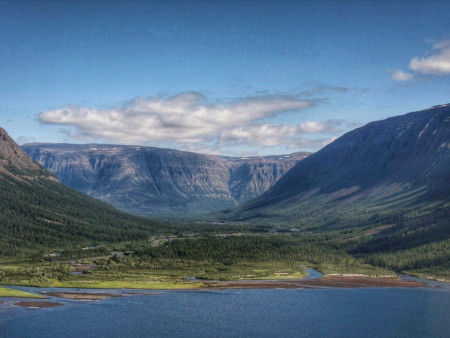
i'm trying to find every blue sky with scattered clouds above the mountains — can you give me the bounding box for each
[0,0,450,156]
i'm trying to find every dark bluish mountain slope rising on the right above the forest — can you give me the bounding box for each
[226,104,450,227]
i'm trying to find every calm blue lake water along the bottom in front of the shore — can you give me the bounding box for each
[0,287,450,338]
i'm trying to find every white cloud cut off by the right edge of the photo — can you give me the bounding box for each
[409,40,450,75]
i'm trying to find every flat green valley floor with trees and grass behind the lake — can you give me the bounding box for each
[0,230,450,295]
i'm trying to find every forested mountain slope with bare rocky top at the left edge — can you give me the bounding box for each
[0,128,162,256]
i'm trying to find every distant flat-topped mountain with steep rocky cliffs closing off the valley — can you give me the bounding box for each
[22,144,308,214]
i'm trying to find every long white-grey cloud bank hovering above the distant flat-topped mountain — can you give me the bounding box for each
[39,92,340,153]
